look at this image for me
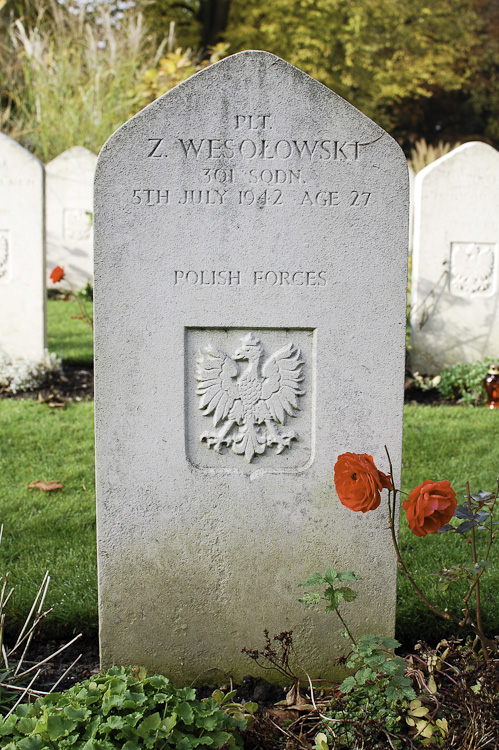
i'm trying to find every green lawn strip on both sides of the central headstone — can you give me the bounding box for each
[0,388,499,645]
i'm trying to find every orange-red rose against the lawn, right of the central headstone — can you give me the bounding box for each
[402,479,457,536]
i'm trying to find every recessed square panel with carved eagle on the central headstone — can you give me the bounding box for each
[186,328,314,473]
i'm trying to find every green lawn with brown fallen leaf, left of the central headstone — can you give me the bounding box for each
[0,400,97,635]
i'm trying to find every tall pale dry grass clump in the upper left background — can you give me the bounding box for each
[0,0,167,162]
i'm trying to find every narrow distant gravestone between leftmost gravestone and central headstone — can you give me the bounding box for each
[45,146,97,290]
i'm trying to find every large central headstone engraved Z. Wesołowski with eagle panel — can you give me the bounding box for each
[95,51,408,682]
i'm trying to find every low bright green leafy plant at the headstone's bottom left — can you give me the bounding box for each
[0,667,255,750]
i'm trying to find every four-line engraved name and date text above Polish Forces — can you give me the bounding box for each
[143,111,382,213]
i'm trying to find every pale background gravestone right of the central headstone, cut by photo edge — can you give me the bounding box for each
[411,143,499,374]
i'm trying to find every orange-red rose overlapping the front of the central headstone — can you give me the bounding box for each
[334,453,393,513]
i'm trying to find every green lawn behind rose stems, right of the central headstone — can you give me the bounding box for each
[397,405,499,645]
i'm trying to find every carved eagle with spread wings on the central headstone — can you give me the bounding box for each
[196,333,305,463]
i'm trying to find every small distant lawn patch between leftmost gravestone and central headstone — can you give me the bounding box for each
[47,299,93,367]
